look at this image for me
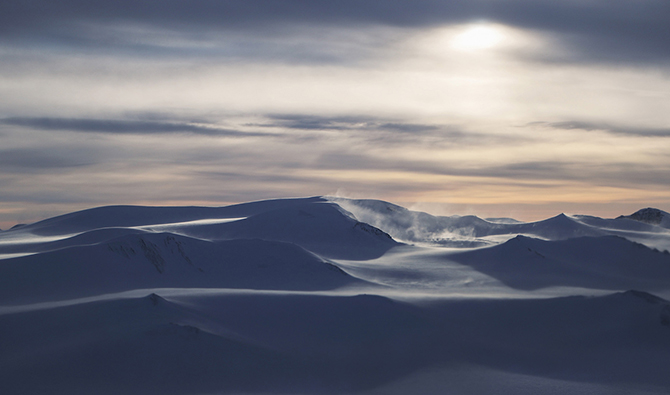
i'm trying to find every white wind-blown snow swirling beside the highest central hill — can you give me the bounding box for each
[326,196,491,247]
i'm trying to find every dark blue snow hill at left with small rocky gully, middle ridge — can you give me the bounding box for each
[0,233,363,304]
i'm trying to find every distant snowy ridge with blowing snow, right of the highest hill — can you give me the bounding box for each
[328,197,670,250]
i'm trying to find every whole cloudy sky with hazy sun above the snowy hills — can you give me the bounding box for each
[0,0,670,229]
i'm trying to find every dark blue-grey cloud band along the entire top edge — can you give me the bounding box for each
[0,0,670,63]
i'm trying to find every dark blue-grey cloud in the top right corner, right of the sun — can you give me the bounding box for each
[489,0,670,65]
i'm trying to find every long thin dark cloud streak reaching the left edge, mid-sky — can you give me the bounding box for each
[0,117,272,137]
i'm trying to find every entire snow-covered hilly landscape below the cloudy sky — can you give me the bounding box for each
[0,197,670,395]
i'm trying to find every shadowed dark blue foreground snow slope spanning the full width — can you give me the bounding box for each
[0,292,670,394]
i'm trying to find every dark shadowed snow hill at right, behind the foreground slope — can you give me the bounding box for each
[450,236,670,291]
